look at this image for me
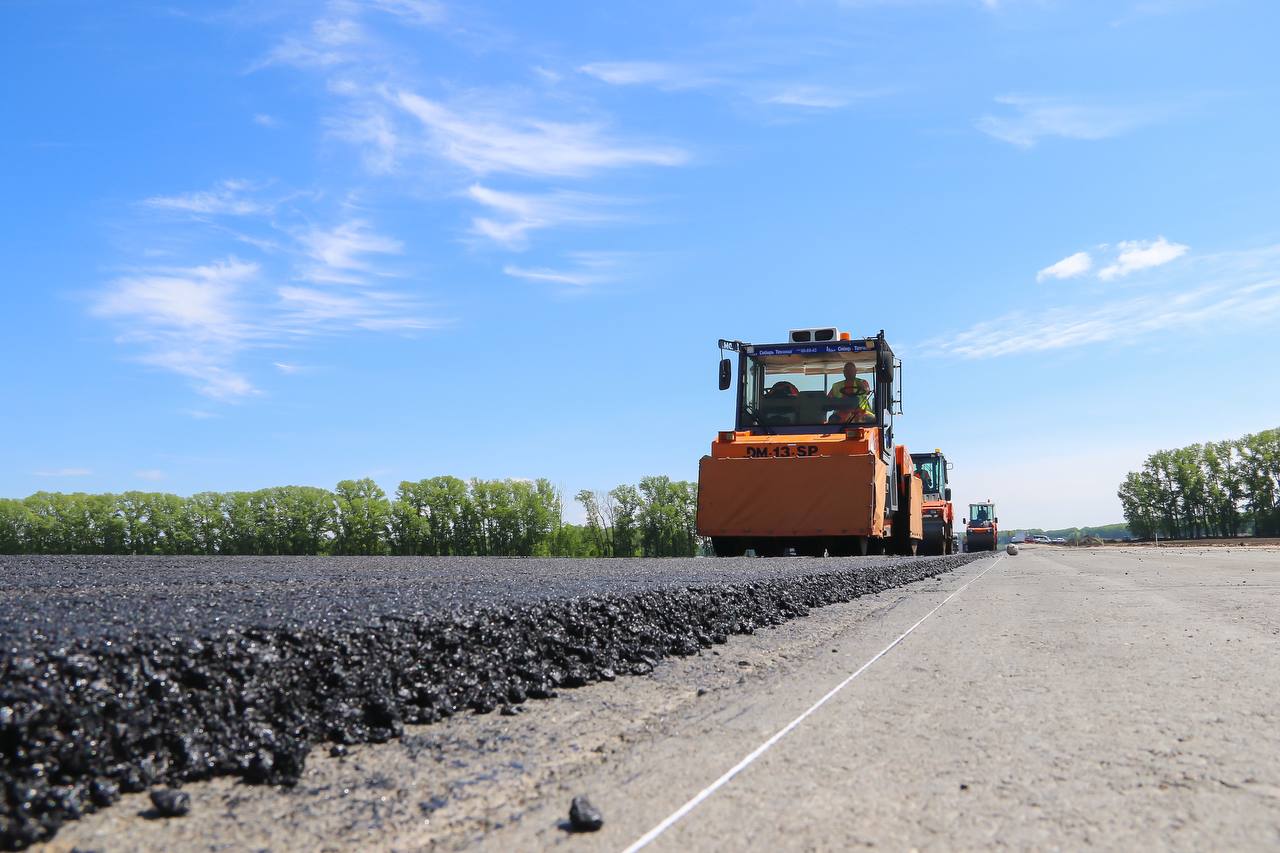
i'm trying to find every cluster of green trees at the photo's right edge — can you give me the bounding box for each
[1119,429,1280,539]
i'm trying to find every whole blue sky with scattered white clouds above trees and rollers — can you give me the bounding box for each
[0,0,1280,526]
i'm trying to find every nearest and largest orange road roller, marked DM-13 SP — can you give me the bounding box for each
[698,328,924,556]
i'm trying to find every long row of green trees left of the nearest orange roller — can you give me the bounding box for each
[0,476,701,557]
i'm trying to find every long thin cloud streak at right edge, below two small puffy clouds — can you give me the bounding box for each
[927,246,1280,359]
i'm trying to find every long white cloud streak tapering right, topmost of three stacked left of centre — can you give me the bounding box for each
[392,91,689,177]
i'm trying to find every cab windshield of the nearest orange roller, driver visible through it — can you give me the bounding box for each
[739,352,877,429]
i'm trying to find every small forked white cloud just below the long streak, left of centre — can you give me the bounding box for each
[467,184,620,248]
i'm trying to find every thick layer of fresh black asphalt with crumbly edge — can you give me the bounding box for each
[0,555,986,849]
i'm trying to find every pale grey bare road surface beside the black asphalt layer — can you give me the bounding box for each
[47,547,1280,850]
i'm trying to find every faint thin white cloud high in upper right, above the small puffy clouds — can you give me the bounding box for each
[978,95,1167,147]
